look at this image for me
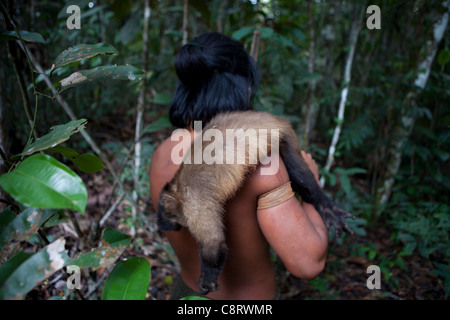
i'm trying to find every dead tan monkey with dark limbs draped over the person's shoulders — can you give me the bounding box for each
[158,111,354,294]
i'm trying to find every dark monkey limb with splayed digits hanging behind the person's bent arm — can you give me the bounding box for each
[282,146,355,237]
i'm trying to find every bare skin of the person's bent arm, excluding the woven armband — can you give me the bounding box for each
[253,153,328,279]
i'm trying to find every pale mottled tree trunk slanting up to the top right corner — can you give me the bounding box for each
[376,1,449,214]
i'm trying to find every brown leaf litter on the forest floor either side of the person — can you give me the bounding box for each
[27,113,446,300]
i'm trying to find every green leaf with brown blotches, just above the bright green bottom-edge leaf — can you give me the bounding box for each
[70,228,131,269]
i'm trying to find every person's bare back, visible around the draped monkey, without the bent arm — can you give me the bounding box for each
[149,131,288,299]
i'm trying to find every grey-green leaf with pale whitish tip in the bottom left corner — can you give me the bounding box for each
[0,238,68,300]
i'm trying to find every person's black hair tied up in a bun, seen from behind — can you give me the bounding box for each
[169,32,259,128]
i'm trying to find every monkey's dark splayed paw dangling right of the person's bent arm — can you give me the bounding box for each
[318,200,355,238]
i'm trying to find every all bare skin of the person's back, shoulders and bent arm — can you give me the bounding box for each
[149,131,328,300]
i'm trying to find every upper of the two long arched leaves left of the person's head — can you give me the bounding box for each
[50,43,119,76]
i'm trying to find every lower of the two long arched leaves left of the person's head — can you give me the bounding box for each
[58,64,144,93]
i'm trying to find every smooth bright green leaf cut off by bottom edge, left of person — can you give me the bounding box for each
[102,257,150,300]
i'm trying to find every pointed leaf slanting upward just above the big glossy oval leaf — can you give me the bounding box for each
[19,119,87,155]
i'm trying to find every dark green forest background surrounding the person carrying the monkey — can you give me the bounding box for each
[0,0,450,299]
